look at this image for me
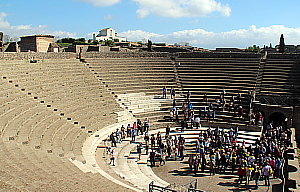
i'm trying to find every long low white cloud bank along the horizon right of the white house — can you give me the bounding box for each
[119,25,300,49]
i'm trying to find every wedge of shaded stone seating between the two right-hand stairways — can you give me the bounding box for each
[172,58,260,125]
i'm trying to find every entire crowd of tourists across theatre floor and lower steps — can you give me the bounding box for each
[106,88,292,188]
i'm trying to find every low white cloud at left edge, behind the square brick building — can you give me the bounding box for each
[0,12,76,40]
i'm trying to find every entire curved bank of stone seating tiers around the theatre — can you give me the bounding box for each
[0,54,300,191]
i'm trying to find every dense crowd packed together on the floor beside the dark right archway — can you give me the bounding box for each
[188,121,291,188]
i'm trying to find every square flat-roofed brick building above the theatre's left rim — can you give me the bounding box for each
[20,35,59,52]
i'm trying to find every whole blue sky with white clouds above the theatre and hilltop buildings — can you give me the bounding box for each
[0,0,300,49]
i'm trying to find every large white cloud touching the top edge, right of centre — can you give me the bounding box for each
[132,0,231,18]
